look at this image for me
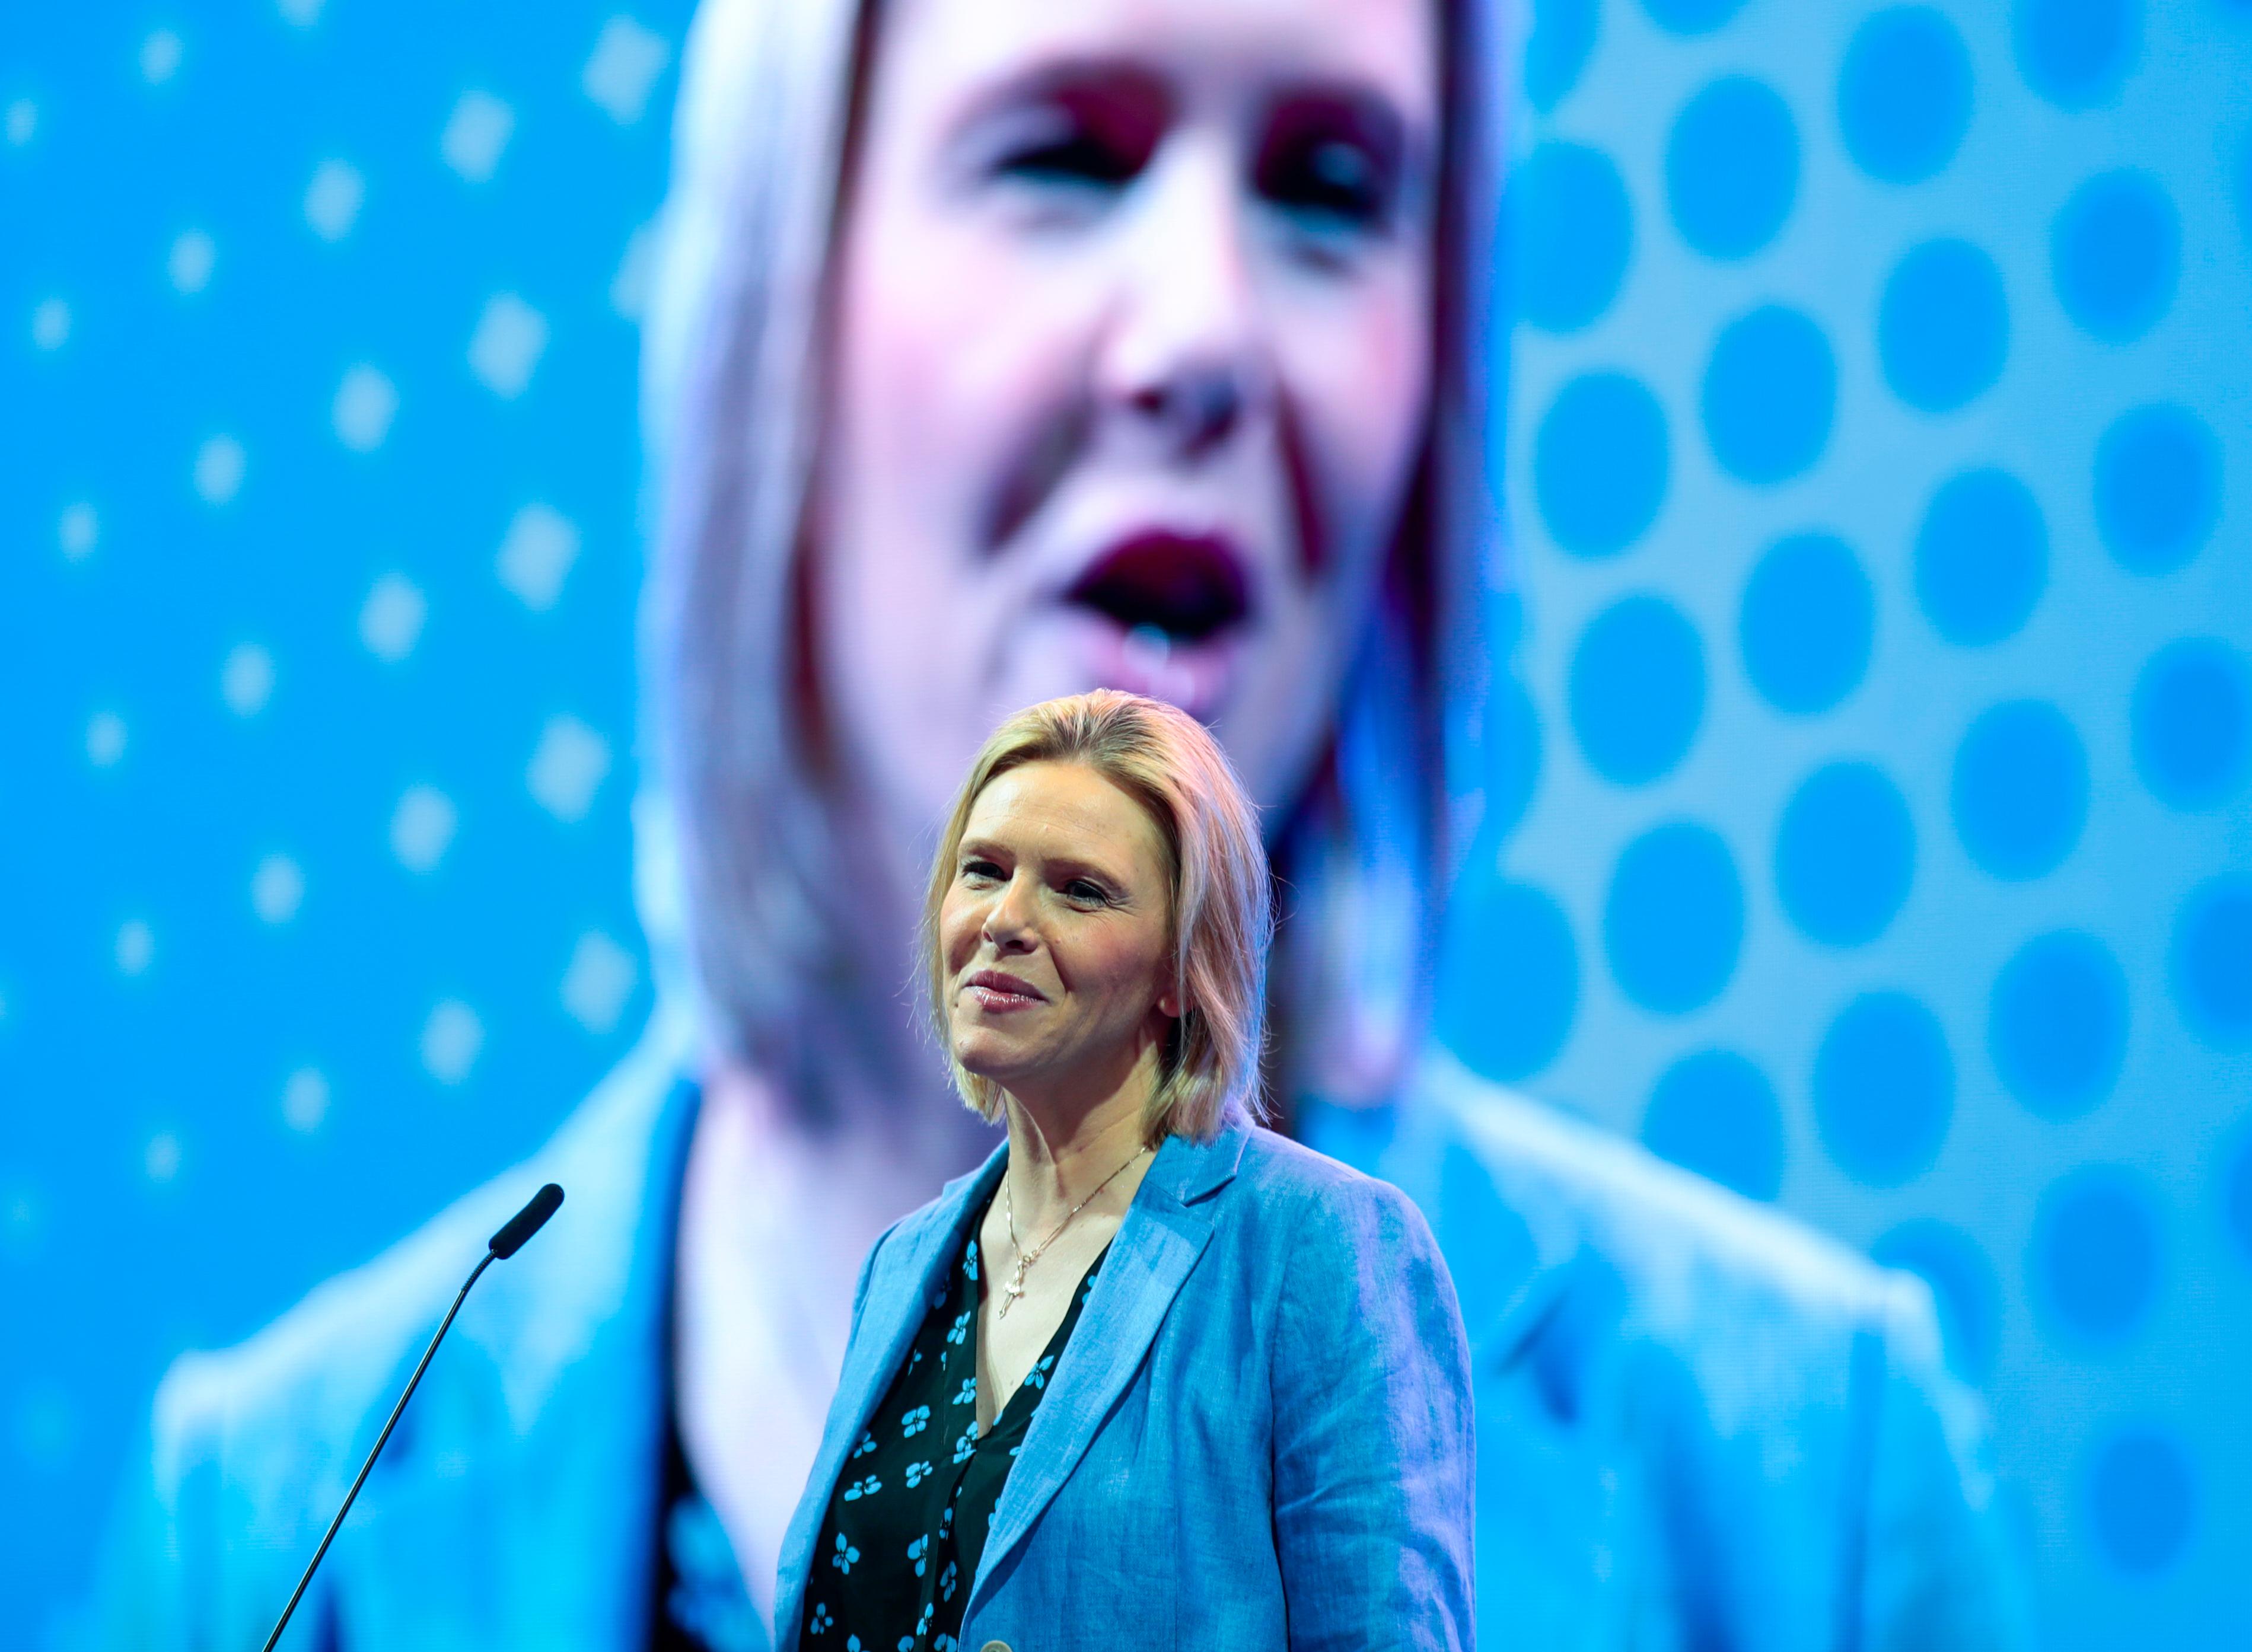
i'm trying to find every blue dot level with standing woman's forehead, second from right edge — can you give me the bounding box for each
[1950,700,2088,882]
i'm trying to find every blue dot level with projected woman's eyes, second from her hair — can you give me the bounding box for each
[1667,74,1799,259]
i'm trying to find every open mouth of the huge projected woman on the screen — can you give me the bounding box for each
[1063,531,1252,720]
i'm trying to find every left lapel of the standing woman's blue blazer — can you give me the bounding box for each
[775,1143,1009,1645]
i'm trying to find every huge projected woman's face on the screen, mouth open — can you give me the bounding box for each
[808,0,1439,865]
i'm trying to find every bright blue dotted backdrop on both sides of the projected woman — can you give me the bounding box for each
[0,0,2252,1647]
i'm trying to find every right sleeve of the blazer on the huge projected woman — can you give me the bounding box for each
[1858,1278,2031,1652]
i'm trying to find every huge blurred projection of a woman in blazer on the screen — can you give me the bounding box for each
[108,0,2014,1652]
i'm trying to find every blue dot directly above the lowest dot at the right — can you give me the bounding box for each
[2027,1166,2159,1348]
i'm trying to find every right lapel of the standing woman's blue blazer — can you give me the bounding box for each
[961,1130,1248,1623]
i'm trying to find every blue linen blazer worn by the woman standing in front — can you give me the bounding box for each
[775,1130,1475,1652]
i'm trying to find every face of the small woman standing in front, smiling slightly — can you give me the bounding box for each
[939,763,1180,1098]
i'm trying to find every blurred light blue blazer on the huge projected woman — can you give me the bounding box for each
[83,1038,2025,1652]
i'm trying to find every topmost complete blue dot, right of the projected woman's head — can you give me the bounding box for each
[1837,7,1970,184]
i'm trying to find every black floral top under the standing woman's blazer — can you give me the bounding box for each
[799,1236,1110,1652]
